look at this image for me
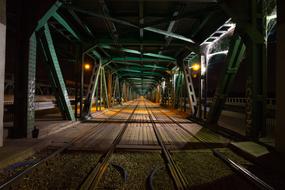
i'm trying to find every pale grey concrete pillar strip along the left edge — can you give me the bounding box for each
[0,0,6,147]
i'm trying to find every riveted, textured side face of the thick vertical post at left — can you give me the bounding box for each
[26,32,37,138]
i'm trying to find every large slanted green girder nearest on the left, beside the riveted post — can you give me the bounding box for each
[38,24,75,121]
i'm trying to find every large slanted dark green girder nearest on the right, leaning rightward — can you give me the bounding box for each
[207,35,245,124]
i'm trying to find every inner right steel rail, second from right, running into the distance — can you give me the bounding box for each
[144,101,189,190]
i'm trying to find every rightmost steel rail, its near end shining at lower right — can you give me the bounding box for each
[149,99,274,190]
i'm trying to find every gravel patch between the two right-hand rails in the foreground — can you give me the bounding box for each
[173,149,257,190]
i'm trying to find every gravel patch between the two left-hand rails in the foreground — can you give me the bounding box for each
[6,152,101,190]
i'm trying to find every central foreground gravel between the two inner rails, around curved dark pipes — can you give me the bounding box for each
[98,152,174,190]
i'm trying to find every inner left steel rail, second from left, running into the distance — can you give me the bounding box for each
[79,100,139,190]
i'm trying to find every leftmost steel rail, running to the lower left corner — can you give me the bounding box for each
[0,101,133,190]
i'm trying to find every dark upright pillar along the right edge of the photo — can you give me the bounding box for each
[275,0,285,154]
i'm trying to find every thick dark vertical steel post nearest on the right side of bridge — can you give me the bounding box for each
[245,0,267,139]
